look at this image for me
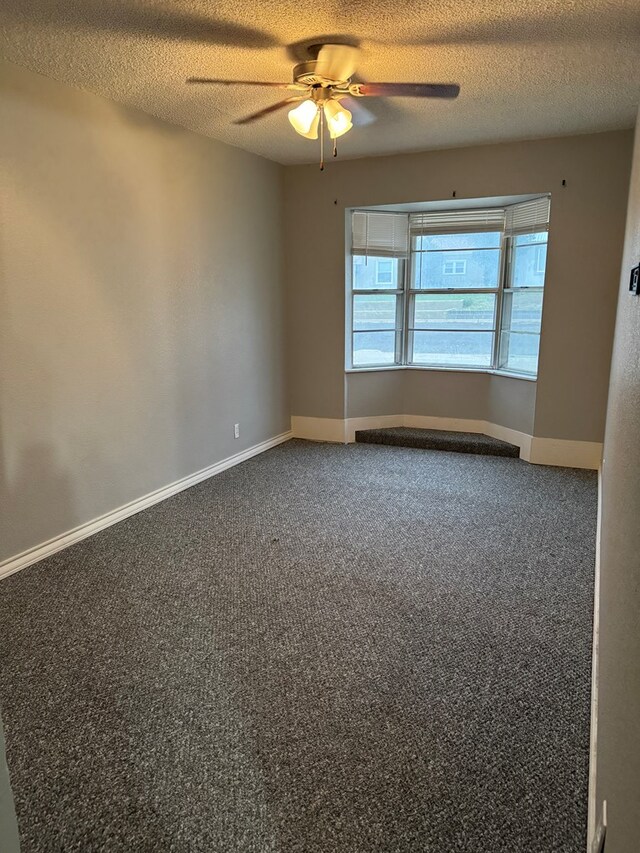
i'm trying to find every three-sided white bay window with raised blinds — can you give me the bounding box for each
[347,196,549,376]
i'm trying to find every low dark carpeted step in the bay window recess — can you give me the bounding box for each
[356,427,520,459]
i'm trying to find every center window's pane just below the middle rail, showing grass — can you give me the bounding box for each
[413,293,498,330]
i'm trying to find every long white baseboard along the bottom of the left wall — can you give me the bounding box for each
[0,432,293,579]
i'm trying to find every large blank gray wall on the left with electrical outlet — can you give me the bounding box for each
[0,64,289,560]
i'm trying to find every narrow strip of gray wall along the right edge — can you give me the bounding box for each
[596,106,640,853]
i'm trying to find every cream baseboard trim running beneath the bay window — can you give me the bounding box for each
[291,415,602,471]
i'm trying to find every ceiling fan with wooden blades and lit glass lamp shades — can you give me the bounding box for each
[187,44,460,169]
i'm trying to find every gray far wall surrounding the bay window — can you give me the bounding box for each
[285,135,632,441]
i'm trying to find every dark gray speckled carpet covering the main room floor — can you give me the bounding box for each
[0,441,596,853]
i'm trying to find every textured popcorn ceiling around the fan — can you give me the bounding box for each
[0,0,640,163]
